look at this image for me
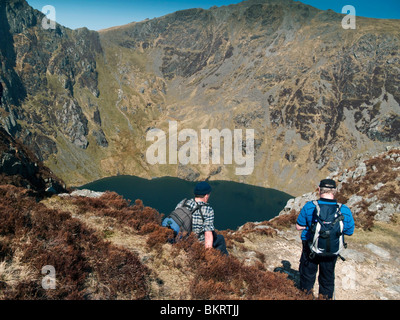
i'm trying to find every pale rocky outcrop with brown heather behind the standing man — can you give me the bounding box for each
[279,147,400,228]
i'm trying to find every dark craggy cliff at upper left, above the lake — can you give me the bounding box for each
[0,0,102,160]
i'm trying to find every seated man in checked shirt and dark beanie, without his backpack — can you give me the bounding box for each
[176,181,228,255]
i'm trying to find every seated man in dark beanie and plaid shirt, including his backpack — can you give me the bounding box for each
[162,181,228,255]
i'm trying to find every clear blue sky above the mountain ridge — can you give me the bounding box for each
[27,0,400,30]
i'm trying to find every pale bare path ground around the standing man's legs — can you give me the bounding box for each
[232,223,400,300]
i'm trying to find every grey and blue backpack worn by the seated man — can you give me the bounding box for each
[161,199,204,236]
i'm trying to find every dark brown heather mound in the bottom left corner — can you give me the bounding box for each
[0,186,149,300]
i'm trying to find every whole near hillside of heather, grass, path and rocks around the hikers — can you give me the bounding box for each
[0,144,400,300]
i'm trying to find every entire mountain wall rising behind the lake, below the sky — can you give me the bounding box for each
[0,0,400,195]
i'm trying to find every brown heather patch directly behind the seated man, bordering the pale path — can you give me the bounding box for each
[171,232,307,300]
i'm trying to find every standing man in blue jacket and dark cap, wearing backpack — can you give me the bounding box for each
[296,179,354,299]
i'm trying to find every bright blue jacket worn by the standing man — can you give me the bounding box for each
[297,199,354,240]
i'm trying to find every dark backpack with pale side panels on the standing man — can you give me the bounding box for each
[308,201,347,260]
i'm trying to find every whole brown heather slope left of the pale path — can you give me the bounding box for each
[0,186,307,300]
